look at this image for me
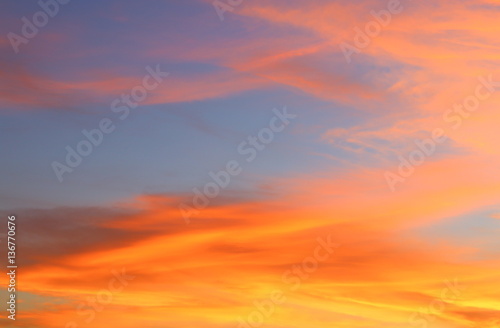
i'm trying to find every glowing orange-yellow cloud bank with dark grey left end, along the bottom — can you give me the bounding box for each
[7,180,495,327]
